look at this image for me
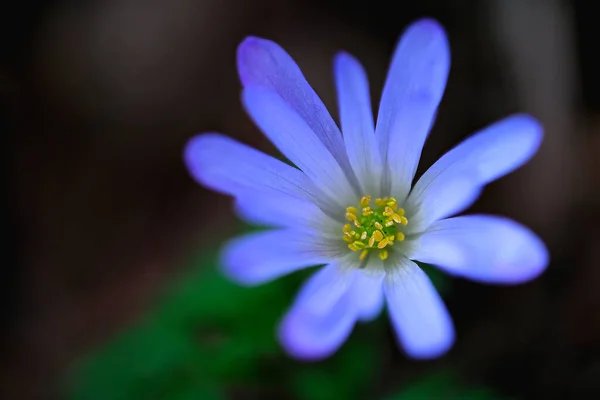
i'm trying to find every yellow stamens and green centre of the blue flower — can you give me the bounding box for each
[343,196,408,260]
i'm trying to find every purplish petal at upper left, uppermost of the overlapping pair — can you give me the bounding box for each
[237,37,358,189]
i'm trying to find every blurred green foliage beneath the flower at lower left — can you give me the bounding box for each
[67,228,468,400]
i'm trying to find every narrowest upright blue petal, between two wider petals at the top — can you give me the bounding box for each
[334,53,382,196]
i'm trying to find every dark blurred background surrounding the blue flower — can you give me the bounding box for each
[0,0,600,400]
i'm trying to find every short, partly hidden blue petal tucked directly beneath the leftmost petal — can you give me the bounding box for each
[236,192,341,236]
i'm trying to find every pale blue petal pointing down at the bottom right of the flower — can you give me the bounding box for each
[384,259,454,359]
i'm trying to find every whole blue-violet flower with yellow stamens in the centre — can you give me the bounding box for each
[185,19,549,359]
